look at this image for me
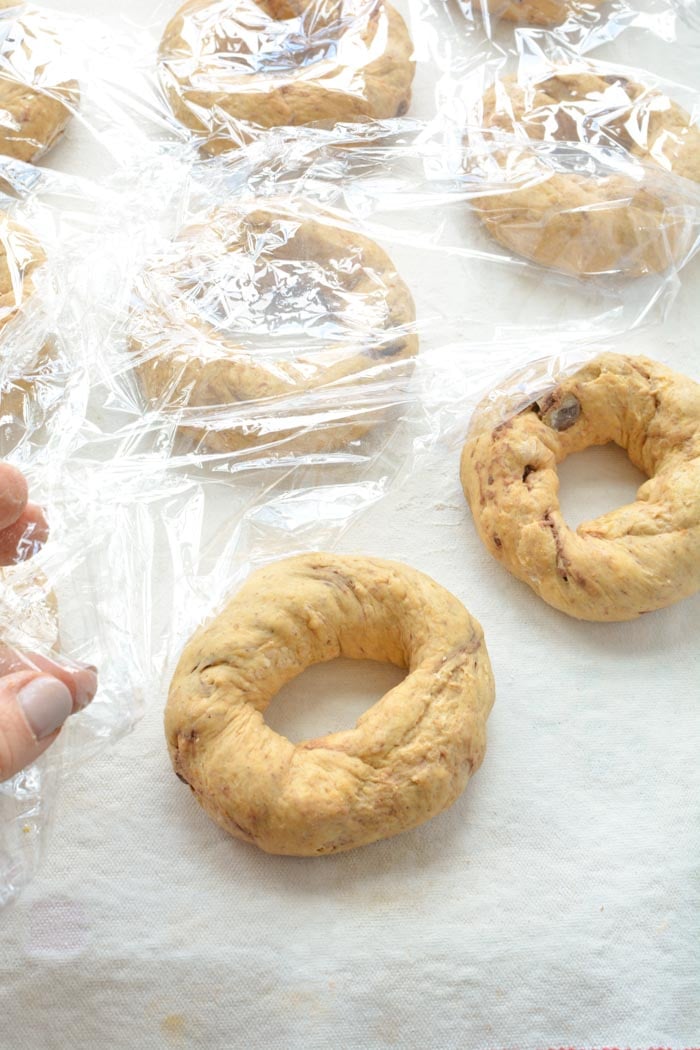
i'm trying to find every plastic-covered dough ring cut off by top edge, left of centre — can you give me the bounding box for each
[160,0,415,152]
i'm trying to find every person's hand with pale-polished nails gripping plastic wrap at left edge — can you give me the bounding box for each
[0,463,98,781]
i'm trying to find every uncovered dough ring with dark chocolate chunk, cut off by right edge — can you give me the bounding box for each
[461,354,700,622]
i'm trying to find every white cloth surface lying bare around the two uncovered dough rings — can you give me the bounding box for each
[0,0,700,1050]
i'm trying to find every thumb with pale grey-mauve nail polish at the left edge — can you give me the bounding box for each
[0,671,89,781]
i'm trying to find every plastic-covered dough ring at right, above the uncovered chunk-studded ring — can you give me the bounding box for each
[473,67,700,277]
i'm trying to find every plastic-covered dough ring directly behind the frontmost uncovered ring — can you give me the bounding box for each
[127,197,418,454]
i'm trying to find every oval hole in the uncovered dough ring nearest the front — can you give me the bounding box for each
[264,659,406,743]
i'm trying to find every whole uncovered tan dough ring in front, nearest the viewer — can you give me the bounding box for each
[165,553,494,857]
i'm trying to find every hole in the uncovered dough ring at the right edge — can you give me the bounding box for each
[557,444,646,528]
